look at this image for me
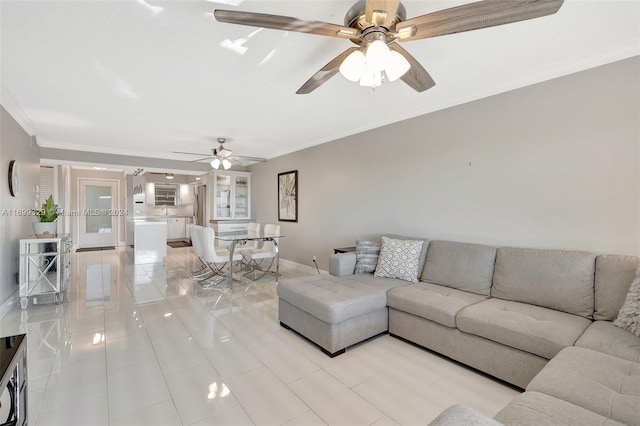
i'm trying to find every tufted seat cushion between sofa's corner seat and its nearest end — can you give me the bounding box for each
[527,347,640,425]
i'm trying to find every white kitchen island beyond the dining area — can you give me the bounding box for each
[133,218,167,264]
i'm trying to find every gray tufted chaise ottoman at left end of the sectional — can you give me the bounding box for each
[278,275,389,357]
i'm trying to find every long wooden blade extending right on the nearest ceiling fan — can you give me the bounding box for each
[396,0,564,41]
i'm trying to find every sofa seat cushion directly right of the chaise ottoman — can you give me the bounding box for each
[387,283,486,327]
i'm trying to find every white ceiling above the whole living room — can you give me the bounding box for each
[0,0,640,171]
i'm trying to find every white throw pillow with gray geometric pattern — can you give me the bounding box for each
[373,237,424,283]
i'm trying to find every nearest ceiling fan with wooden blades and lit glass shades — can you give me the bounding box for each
[214,0,564,94]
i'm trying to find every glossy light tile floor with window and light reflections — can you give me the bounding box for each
[1,247,518,426]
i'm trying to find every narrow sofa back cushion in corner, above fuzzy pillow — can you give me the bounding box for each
[593,254,640,321]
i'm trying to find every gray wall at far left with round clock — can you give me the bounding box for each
[0,106,40,306]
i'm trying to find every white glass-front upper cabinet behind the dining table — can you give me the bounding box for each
[213,172,251,220]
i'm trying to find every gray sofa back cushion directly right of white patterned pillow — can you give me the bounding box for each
[421,241,496,296]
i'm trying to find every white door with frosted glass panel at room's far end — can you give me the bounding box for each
[78,179,120,247]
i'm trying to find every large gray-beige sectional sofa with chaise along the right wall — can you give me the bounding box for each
[278,240,640,425]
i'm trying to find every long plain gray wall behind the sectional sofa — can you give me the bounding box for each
[251,57,640,269]
